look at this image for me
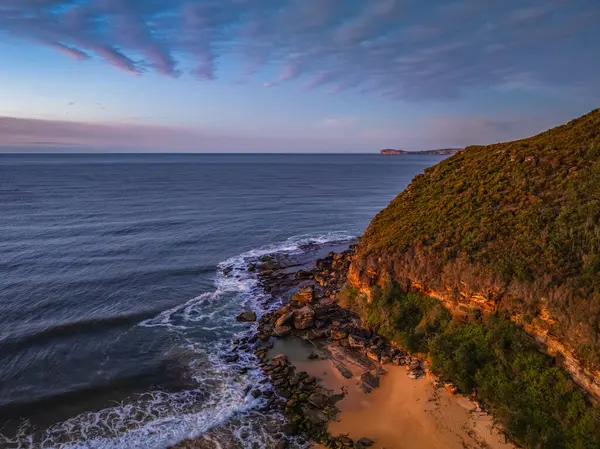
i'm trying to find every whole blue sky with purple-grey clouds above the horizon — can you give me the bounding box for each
[0,0,600,153]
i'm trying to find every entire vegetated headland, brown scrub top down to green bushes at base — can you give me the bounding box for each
[342,109,600,449]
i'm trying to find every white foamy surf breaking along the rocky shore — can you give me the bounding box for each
[5,232,353,449]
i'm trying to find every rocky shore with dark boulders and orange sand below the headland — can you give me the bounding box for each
[185,247,516,449]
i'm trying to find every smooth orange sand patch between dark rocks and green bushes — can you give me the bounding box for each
[272,339,515,449]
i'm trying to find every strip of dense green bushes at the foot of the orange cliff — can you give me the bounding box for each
[343,286,600,449]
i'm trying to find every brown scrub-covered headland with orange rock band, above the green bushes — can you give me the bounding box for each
[348,110,600,400]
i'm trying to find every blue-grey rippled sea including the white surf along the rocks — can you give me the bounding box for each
[0,155,441,448]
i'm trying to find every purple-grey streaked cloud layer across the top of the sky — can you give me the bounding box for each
[0,0,600,100]
